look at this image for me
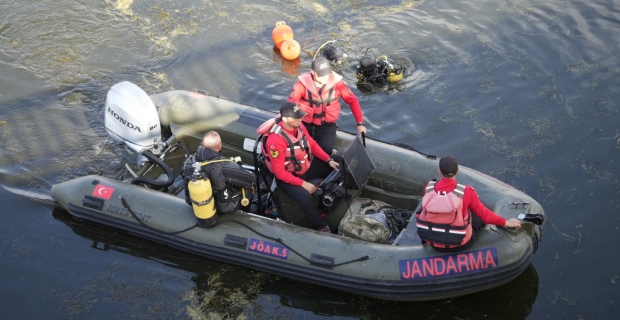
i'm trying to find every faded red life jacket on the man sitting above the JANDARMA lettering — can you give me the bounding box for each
[416,181,472,248]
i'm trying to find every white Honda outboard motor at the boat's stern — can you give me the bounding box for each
[105,81,165,167]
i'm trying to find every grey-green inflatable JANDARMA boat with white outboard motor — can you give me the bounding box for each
[51,82,545,301]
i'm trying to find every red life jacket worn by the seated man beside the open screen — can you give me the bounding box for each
[257,119,312,176]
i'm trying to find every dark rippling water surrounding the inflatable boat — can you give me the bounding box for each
[0,0,620,319]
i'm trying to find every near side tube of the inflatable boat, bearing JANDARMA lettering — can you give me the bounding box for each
[52,172,532,301]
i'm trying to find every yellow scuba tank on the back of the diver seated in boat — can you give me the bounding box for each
[187,179,217,227]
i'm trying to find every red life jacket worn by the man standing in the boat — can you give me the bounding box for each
[298,72,342,125]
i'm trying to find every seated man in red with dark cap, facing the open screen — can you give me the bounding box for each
[263,102,339,232]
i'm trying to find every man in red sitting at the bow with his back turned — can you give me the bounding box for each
[416,155,521,252]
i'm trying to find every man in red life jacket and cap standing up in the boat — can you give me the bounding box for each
[288,57,366,155]
